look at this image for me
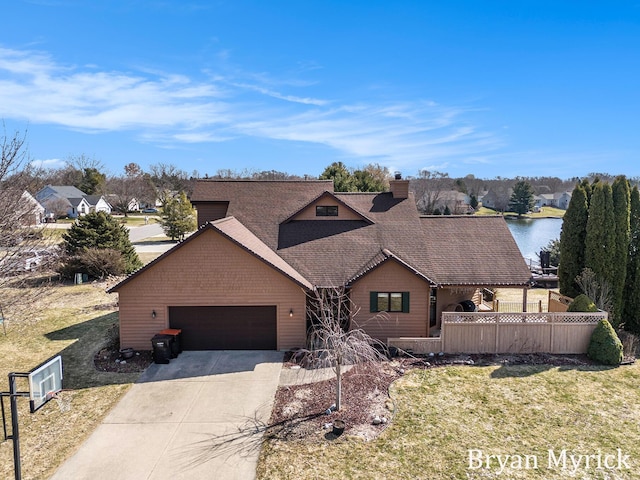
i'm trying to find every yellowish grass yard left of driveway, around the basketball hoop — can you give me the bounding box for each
[0,283,139,480]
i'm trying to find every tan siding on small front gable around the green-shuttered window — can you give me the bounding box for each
[351,261,429,342]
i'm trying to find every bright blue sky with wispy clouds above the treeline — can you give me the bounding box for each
[0,0,640,178]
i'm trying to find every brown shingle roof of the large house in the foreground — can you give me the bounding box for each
[117,180,531,288]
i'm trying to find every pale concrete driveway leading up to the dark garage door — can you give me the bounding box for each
[51,351,282,480]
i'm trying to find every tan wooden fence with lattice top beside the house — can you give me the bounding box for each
[388,312,607,354]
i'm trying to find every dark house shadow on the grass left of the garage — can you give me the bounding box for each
[45,312,141,390]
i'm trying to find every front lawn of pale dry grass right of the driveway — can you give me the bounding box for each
[258,364,640,480]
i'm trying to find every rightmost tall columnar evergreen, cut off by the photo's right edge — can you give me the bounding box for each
[622,186,640,334]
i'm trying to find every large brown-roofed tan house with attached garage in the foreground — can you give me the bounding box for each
[109,179,531,350]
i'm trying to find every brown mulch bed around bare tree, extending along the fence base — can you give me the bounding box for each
[267,354,593,442]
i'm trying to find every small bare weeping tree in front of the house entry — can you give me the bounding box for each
[305,287,386,410]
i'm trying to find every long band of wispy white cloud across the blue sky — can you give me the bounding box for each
[0,48,503,168]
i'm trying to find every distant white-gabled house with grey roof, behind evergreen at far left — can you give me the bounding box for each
[35,185,111,218]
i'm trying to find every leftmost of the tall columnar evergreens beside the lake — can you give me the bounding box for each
[558,184,589,298]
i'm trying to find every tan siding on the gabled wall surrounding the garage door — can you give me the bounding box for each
[118,230,306,350]
